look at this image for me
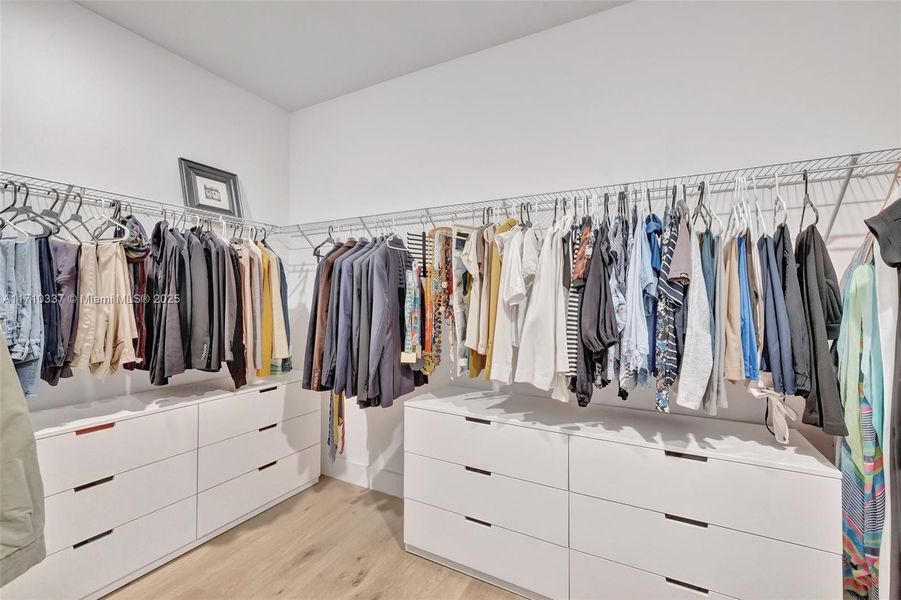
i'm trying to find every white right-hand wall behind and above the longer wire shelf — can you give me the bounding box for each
[290,2,901,493]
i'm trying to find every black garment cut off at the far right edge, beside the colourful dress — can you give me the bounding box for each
[866,199,901,600]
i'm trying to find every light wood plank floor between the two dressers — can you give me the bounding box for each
[107,477,517,600]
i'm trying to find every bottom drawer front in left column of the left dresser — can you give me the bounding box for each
[2,498,196,600]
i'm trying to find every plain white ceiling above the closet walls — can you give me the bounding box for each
[79,0,625,111]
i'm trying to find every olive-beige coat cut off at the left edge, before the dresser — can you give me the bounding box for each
[0,332,46,586]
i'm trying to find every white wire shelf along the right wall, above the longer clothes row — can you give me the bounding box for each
[273,148,901,248]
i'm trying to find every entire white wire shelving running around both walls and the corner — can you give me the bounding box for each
[0,148,901,248]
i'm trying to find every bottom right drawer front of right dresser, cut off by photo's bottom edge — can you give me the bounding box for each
[569,550,728,600]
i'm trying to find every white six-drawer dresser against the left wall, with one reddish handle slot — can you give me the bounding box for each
[0,377,320,600]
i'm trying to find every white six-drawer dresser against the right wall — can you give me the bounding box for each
[404,387,842,600]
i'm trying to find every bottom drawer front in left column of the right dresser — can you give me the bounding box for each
[404,500,569,598]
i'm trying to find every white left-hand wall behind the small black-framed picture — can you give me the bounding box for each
[0,1,288,408]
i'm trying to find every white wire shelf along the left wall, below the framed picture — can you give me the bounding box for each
[0,171,278,232]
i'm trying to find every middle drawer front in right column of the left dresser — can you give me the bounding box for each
[198,411,320,490]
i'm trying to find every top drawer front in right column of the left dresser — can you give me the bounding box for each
[200,383,320,446]
